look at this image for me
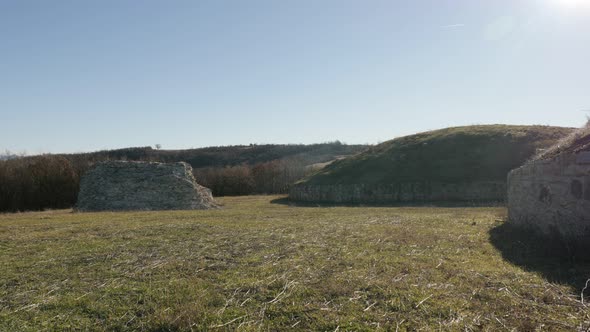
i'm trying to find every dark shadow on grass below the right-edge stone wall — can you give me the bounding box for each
[489,222,590,296]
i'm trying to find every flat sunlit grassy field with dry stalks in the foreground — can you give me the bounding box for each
[0,196,590,331]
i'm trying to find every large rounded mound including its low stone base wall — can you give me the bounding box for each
[291,125,573,202]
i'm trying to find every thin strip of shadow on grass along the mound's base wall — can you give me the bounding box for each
[270,197,506,208]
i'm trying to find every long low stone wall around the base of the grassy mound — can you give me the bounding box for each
[289,181,506,204]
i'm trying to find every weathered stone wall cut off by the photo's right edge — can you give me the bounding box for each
[508,154,590,243]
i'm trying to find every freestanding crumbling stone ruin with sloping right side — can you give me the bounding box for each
[76,161,217,211]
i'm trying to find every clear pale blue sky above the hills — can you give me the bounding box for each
[0,0,590,153]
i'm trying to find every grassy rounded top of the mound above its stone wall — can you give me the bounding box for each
[300,125,573,185]
